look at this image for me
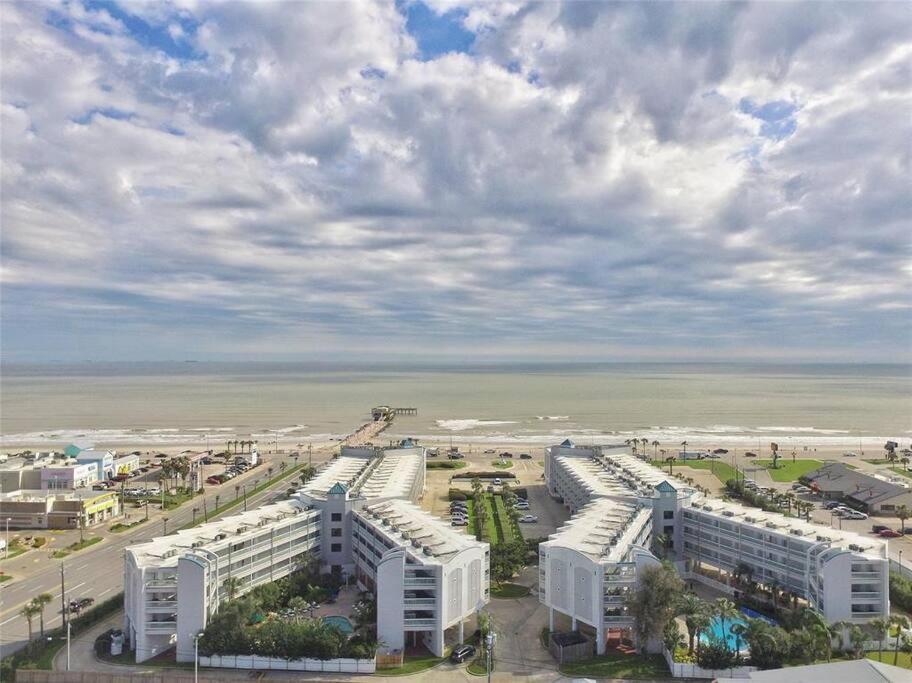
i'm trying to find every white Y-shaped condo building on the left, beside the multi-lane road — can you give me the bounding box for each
[124,446,489,662]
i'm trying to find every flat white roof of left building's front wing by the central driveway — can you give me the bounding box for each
[357,499,488,564]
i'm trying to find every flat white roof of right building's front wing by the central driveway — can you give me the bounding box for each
[545,498,652,562]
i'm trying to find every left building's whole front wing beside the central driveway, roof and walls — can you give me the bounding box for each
[352,500,490,657]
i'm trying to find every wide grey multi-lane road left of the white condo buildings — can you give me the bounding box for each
[0,451,330,657]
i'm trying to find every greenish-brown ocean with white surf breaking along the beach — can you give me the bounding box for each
[0,362,912,448]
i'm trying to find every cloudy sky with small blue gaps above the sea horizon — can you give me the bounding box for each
[0,0,912,361]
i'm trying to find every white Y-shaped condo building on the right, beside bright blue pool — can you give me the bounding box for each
[539,441,890,653]
